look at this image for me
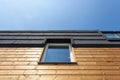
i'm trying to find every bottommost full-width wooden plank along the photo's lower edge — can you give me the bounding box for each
[0,75,120,80]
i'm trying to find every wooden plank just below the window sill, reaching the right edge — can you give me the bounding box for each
[36,65,120,70]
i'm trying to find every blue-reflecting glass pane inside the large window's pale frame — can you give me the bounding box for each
[44,46,70,62]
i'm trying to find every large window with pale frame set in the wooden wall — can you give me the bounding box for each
[42,43,73,63]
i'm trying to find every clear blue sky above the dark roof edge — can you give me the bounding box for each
[0,0,120,31]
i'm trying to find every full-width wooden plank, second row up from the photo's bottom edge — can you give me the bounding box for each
[0,70,120,75]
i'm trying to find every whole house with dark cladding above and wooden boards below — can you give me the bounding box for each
[0,30,120,80]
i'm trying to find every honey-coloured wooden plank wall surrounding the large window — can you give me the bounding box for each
[0,48,120,80]
